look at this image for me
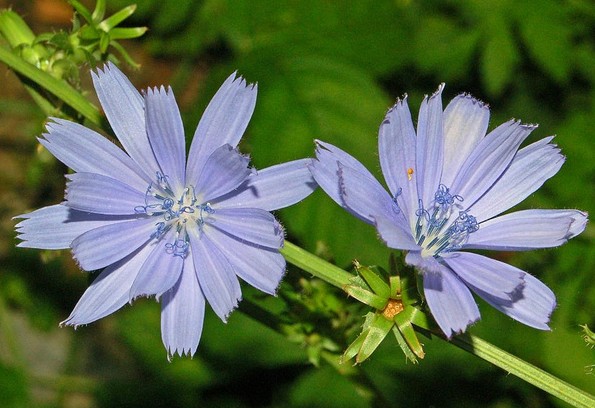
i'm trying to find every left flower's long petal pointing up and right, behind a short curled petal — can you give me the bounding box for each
[186,73,257,185]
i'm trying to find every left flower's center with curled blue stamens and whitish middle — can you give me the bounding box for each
[134,172,215,257]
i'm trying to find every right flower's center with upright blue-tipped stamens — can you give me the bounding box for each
[414,184,479,257]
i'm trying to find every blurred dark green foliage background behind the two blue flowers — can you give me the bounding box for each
[0,0,595,407]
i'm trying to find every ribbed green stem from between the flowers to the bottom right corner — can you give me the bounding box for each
[281,241,595,408]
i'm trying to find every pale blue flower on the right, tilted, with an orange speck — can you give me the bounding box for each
[310,85,587,337]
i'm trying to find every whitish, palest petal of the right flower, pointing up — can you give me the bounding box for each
[441,94,490,187]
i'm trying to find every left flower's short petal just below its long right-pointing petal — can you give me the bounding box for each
[205,208,283,249]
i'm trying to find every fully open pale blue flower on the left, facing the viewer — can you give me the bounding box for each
[16,64,316,356]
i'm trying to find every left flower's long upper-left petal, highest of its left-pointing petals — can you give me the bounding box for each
[39,118,151,191]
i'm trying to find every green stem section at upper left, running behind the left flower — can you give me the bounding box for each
[0,47,101,125]
